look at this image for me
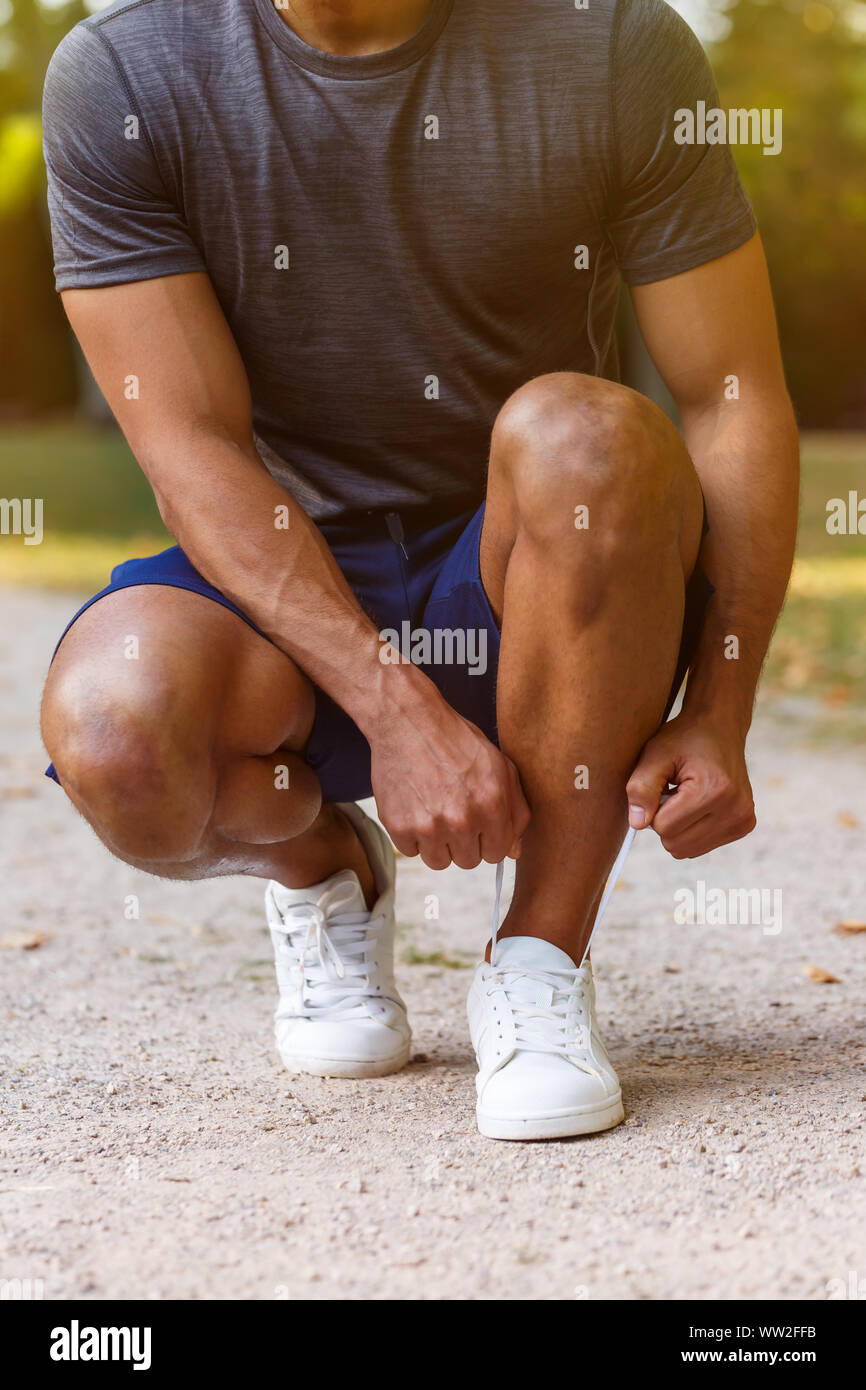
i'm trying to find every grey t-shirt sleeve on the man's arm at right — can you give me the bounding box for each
[607,0,755,285]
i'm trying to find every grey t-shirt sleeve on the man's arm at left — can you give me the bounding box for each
[43,24,204,291]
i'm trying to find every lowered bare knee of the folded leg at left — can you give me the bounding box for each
[42,669,215,863]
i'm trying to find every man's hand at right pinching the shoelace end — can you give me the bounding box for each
[626,713,755,859]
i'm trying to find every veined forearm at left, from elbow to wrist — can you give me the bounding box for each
[145,427,438,737]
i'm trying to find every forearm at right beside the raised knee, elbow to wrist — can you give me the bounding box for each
[684,389,799,737]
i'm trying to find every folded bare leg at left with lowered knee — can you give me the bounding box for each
[42,585,374,904]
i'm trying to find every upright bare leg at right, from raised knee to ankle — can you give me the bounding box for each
[481,373,702,959]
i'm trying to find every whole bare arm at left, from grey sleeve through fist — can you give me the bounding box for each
[63,272,528,867]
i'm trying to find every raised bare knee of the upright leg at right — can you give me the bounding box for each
[492,371,694,545]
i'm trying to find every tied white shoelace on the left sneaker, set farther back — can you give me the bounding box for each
[277,883,382,1019]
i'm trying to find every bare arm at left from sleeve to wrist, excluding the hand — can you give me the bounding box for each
[63,274,419,728]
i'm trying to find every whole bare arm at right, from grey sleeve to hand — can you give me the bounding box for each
[630,236,799,858]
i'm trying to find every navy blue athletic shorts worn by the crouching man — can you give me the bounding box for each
[47,505,713,801]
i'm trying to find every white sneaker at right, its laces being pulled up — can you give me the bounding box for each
[468,937,624,1138]
